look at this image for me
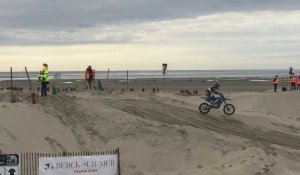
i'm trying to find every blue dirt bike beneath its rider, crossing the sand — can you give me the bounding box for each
[199,95,235,115]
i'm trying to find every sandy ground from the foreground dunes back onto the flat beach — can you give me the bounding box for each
[0,78,300,175]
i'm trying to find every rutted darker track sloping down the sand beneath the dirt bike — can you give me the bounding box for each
[103,99,300,150]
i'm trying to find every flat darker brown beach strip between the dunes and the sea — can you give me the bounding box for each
[0,77,276,93]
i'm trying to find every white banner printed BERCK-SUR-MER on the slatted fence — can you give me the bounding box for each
[39,155,118,175]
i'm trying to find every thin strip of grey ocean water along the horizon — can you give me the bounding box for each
[0,69,300,80]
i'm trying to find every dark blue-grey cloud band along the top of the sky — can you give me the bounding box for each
[0,0,300,30]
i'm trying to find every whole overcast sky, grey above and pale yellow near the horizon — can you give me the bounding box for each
[0,0,300,71]
